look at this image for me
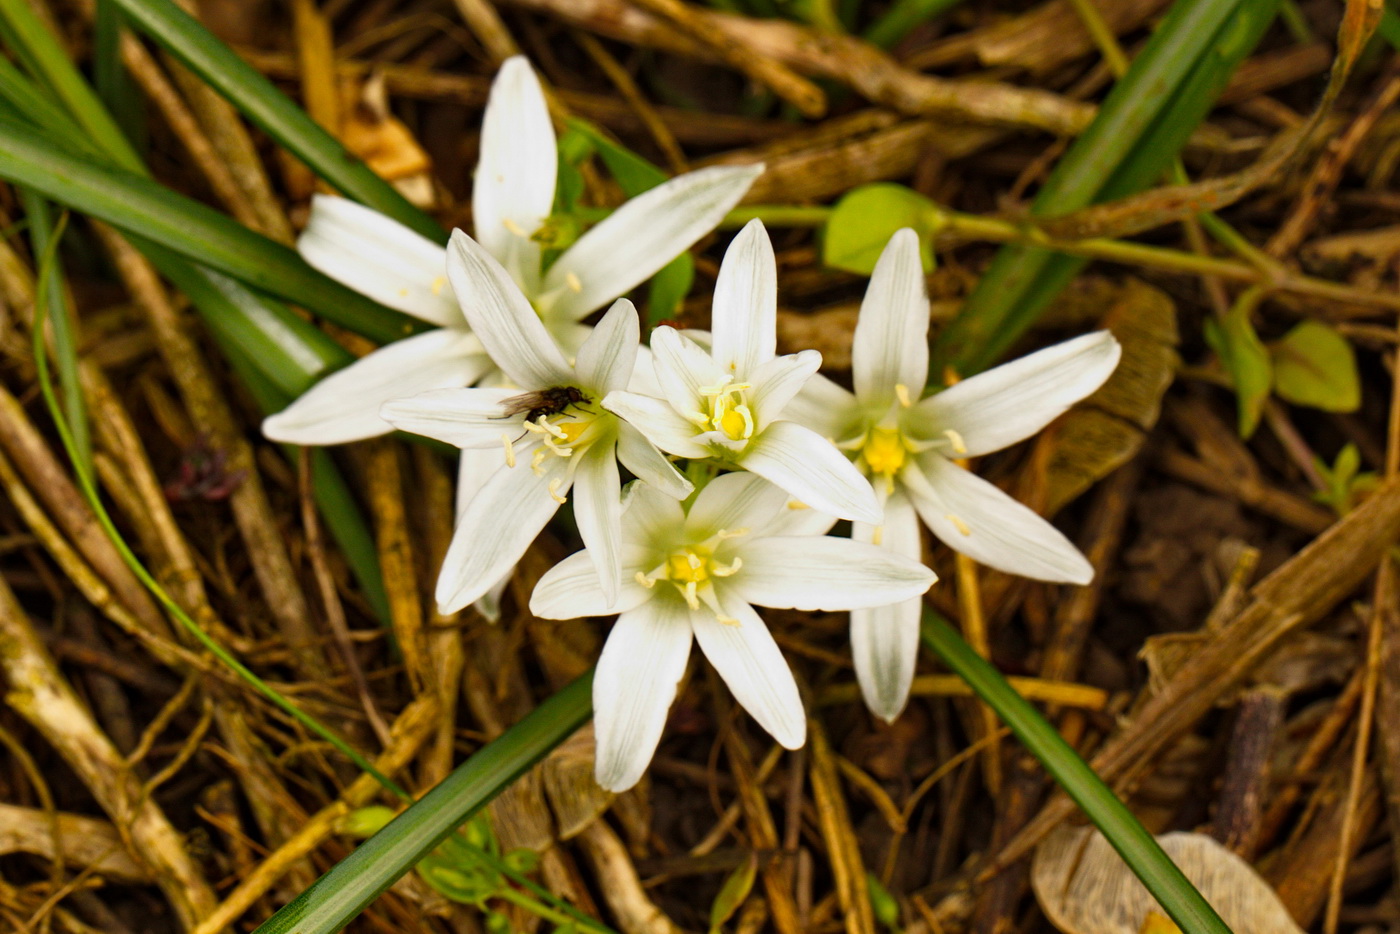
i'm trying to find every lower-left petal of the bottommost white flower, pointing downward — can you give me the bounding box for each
[594,599,690,791]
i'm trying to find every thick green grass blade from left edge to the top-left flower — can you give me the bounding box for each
[0,119,426,343]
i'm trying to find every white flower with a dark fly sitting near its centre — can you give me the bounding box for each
[381,231,692,613]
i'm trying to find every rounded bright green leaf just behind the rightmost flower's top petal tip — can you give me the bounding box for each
[822,182,939,276]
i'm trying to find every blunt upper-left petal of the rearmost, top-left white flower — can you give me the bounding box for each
[297,195,462,328]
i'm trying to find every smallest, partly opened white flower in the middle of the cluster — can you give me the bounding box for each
[603,220,879,522]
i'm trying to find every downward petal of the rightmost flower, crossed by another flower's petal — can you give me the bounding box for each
[851,490,924,723]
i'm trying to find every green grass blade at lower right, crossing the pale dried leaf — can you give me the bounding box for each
[921,609,1231,934]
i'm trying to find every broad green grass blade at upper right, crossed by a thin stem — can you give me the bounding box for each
[932,0,1277,379]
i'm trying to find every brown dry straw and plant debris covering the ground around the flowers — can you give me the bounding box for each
[0,0,1400,934]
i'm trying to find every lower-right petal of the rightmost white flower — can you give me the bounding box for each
[900,452,1093,584]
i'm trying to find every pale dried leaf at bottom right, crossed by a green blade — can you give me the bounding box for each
[1030,826,1302,934]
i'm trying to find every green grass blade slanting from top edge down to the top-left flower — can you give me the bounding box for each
[108,0,447,244]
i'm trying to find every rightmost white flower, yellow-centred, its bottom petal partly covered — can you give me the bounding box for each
[787,230,1121,720]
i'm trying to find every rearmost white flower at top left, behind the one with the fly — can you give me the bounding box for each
[263,56,763,444]
